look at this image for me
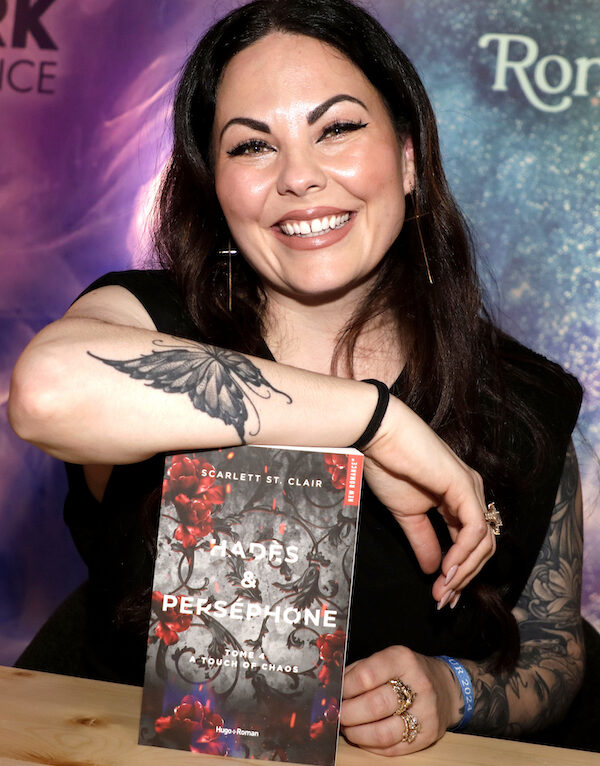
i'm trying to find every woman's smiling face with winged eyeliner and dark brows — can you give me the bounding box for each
[213,33,414,302]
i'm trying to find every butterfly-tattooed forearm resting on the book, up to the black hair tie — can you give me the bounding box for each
[9,318,377,464]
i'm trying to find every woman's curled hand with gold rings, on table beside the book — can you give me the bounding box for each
[341,646,462,755]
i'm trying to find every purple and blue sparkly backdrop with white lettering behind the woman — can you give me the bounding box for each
[0,0,600,664]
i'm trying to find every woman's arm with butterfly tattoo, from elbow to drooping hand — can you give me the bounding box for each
[9,287,494,600]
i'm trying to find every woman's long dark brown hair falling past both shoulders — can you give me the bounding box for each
[155,0,576,662]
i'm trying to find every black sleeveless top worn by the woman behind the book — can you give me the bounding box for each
[65,271,581,684]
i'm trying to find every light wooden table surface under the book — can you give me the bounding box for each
[0,667,600,766]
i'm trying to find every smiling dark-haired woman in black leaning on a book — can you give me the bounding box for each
[10,0,584,754]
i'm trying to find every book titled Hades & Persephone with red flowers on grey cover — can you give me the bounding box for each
[139,445,363,766]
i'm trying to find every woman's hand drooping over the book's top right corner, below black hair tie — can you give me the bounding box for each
[365,397,496,606]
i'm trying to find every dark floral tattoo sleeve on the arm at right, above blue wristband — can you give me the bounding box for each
[466,444,584,736]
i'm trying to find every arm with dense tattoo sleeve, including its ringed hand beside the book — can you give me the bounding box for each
[342,445,585,755]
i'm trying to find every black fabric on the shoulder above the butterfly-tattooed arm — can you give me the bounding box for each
[78,269,196,339]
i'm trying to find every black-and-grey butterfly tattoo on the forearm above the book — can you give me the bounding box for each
[88,340,292,444]
